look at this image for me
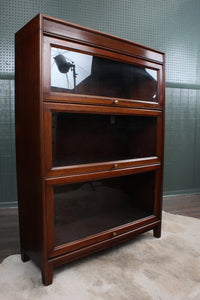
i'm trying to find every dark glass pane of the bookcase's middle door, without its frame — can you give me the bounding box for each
[52,112,157,167]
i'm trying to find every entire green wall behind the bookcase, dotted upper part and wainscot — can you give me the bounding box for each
[0,0,200,206]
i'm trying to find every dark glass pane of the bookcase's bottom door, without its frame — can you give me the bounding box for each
[54,172,155,246]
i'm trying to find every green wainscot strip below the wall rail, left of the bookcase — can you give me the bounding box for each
[0,80,17,207]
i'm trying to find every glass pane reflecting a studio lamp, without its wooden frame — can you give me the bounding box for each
[51,47,157,102]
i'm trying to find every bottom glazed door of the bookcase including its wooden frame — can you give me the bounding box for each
[46,169,160,260]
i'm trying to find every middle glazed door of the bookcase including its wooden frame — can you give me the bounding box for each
[44,103,163,176]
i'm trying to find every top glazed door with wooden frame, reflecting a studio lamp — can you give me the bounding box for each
[44,37,163,108]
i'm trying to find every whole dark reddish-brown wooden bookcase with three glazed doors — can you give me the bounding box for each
[15,14,164,285]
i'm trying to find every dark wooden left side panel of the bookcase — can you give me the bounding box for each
[15,15,45,268]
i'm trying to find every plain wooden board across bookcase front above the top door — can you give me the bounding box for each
[44,16,164,64]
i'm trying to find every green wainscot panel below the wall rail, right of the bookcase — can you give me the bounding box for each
[164,88,200,194]
